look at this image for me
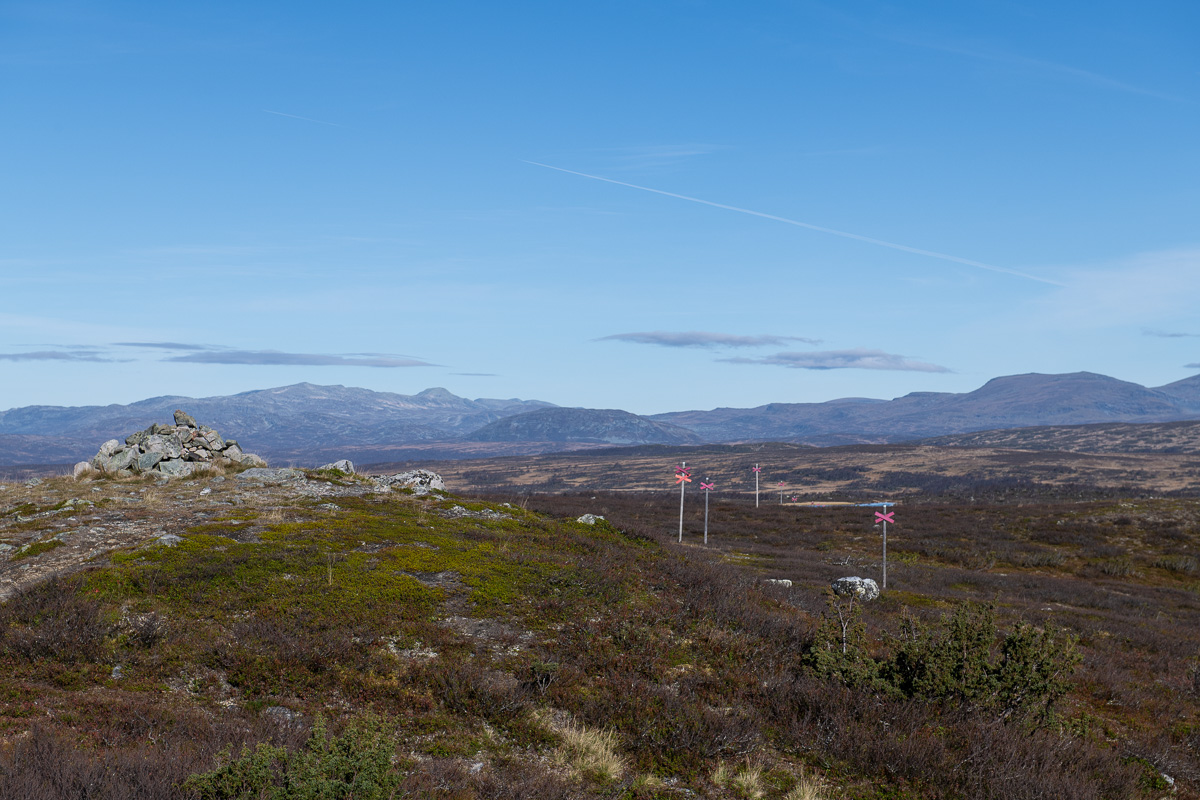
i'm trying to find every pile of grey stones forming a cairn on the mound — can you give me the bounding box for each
[74,410,266,477]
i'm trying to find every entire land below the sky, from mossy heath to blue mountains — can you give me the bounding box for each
[0,373,1200,800]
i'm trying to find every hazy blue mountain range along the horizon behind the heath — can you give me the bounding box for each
[0,372,1200,465]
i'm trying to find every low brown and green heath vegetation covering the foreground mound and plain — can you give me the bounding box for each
[0,465,1200,800]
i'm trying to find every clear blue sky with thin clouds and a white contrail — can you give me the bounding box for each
[0,0,1200,414]
